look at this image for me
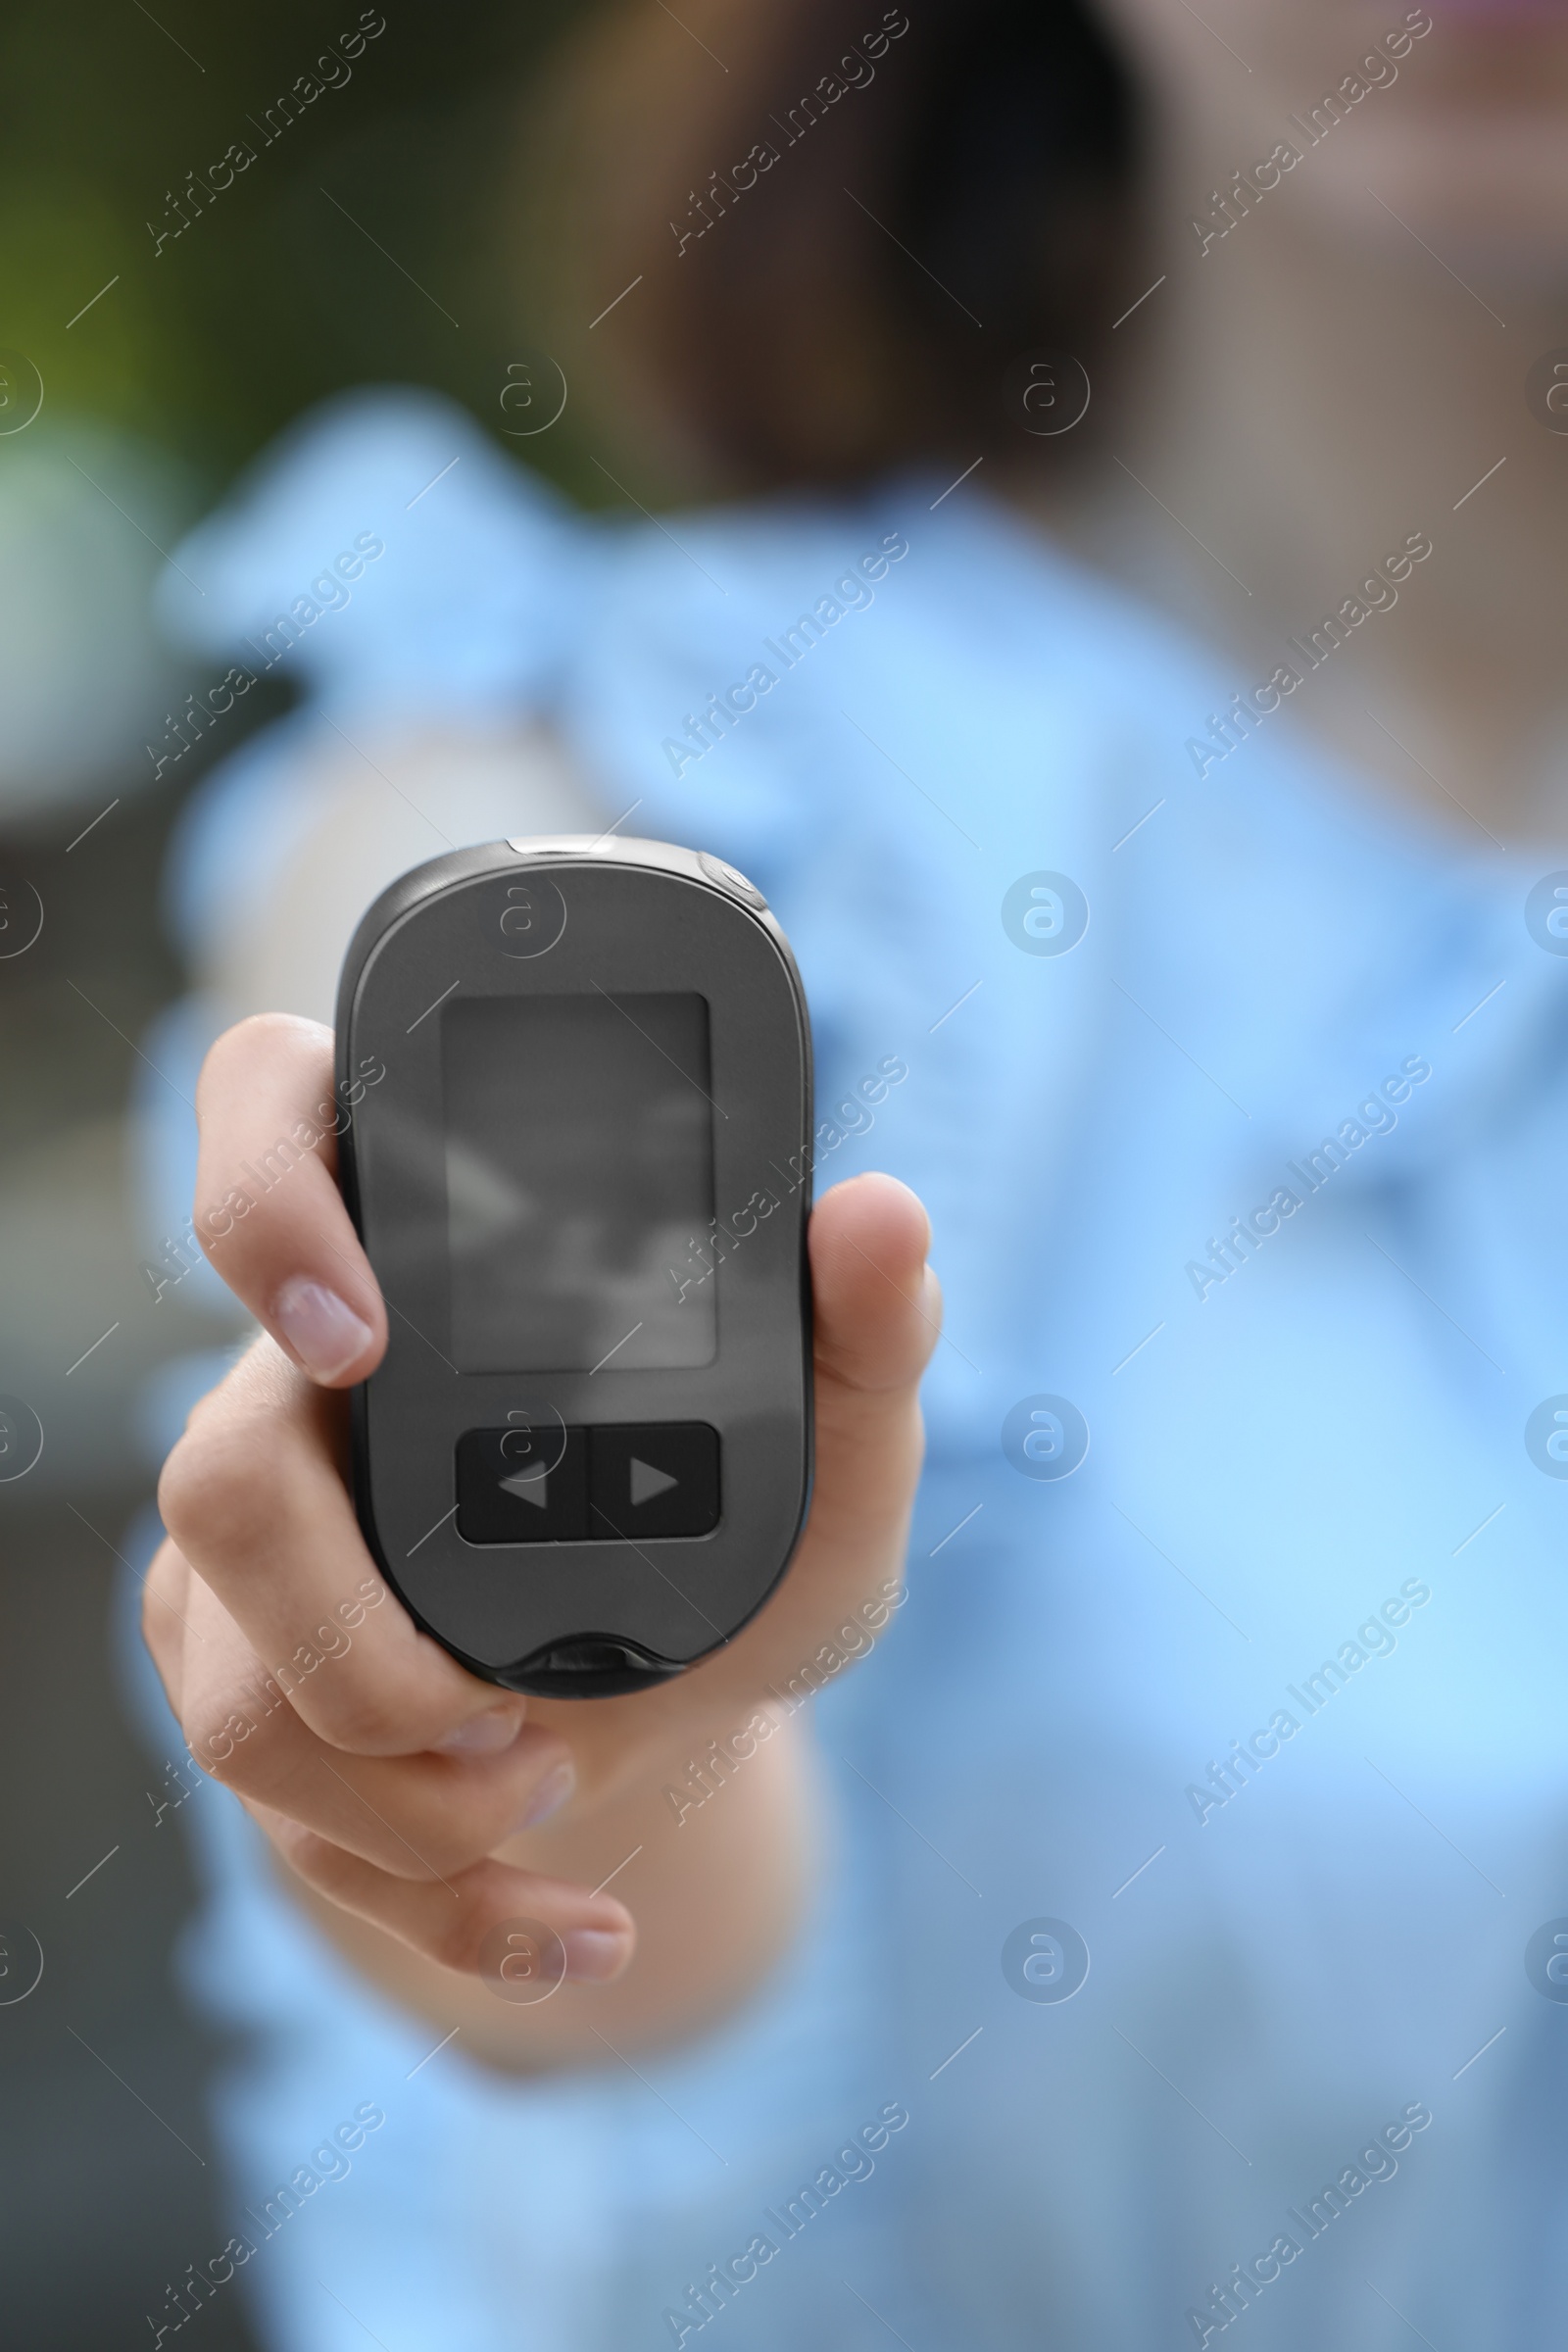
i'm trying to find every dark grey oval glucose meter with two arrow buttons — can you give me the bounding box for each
[336,835,811,1698]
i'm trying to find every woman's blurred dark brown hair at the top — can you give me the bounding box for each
[526,0,1138,489]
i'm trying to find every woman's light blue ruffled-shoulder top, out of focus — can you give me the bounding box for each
[125,395,1568,2352]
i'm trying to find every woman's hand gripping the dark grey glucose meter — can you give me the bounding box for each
[143,1016,941,2006]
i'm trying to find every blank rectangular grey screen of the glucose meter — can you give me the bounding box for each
[442,993,717,1371]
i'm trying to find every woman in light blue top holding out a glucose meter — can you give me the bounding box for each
[131,0,1568,2352]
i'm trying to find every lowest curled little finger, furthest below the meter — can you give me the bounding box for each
[254,1806,637,1983]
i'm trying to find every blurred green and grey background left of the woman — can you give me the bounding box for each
[0,14,604,2352]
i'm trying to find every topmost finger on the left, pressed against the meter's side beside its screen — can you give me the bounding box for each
[195,1013,385,1388]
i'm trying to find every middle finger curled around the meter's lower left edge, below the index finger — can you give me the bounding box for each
[158,1339,526,1754]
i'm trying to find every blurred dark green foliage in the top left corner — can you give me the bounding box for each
[0,0,602,499]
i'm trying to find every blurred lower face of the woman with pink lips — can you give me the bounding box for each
[1101,0,1568,282]
